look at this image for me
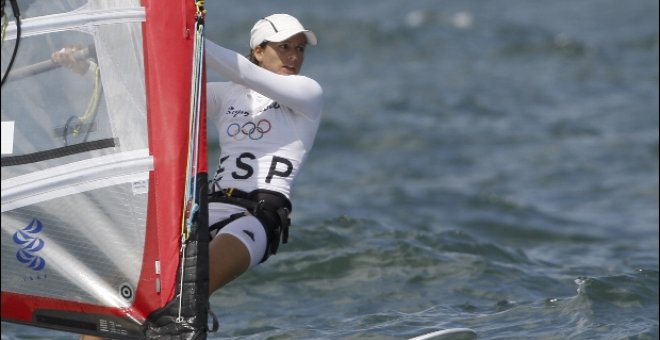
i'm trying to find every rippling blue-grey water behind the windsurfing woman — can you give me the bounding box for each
[2,0,660,340]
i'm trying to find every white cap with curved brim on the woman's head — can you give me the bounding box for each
[250,14,317,48]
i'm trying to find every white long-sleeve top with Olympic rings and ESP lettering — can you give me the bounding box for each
[206,40,323,197]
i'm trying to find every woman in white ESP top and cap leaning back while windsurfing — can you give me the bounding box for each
[206,14,323,293]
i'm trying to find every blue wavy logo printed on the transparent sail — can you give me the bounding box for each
[12,218,46,271]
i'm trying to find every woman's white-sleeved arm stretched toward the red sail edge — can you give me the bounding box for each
[206,40,323,114]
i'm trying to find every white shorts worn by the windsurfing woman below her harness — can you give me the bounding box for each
[209,203,268,267]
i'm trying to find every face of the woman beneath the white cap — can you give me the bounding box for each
[254,33,307,75]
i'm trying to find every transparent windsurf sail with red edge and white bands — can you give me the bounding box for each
[1,0,208,338]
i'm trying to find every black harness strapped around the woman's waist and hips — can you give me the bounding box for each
[209,188,292,262]
